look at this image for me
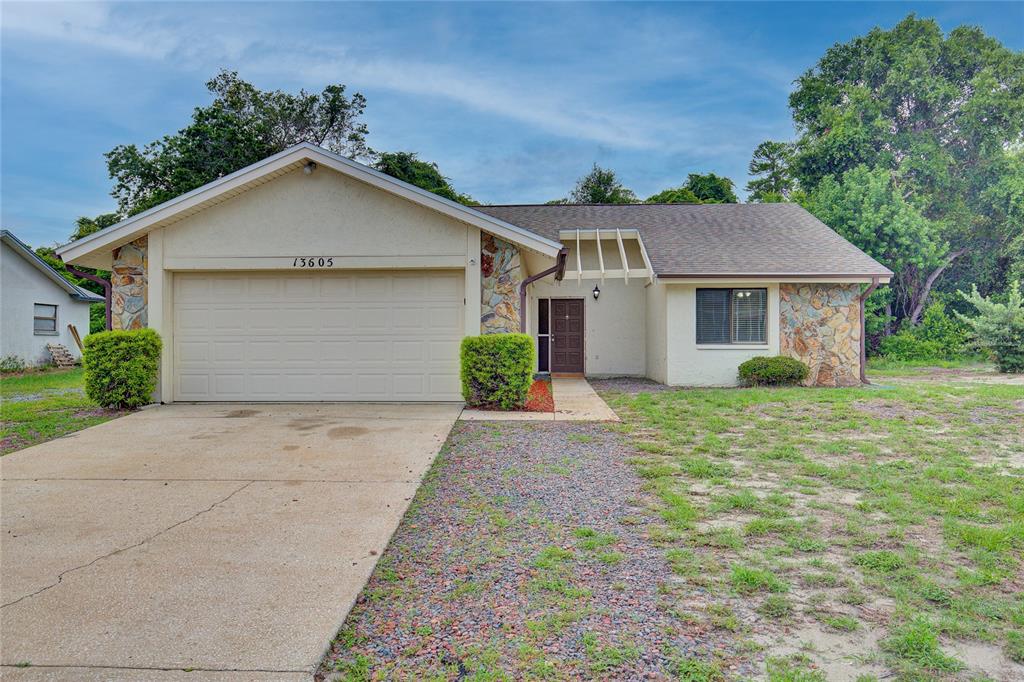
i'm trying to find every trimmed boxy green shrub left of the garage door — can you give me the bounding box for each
[82,329,162,408]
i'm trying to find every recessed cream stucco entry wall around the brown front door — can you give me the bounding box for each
[526,278,646,377]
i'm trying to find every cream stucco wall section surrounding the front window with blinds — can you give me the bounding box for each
[666,282,779,386]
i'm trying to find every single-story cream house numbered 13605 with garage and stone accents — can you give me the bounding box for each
[58,144,892,402]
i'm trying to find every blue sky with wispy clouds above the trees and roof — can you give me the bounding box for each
[0,2,1024,246]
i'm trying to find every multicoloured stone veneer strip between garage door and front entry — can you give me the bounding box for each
[480,232,522,334]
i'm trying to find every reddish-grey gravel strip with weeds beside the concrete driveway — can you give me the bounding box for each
[317,421,734,680]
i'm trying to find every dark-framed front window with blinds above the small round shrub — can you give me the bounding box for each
[697,289,768,344]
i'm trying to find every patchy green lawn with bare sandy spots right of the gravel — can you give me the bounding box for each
[603,372,1024,680]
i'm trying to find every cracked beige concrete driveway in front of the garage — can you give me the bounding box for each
[0,404,461,680]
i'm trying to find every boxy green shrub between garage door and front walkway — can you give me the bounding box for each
[461,334,537,410]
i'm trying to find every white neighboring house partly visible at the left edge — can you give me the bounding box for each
[0,229,103,365]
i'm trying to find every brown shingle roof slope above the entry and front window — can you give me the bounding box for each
[476,204,892,276]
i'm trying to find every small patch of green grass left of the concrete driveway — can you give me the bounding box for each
[0,368,124,455]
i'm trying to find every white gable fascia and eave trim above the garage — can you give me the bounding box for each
[56,142,561,262]
